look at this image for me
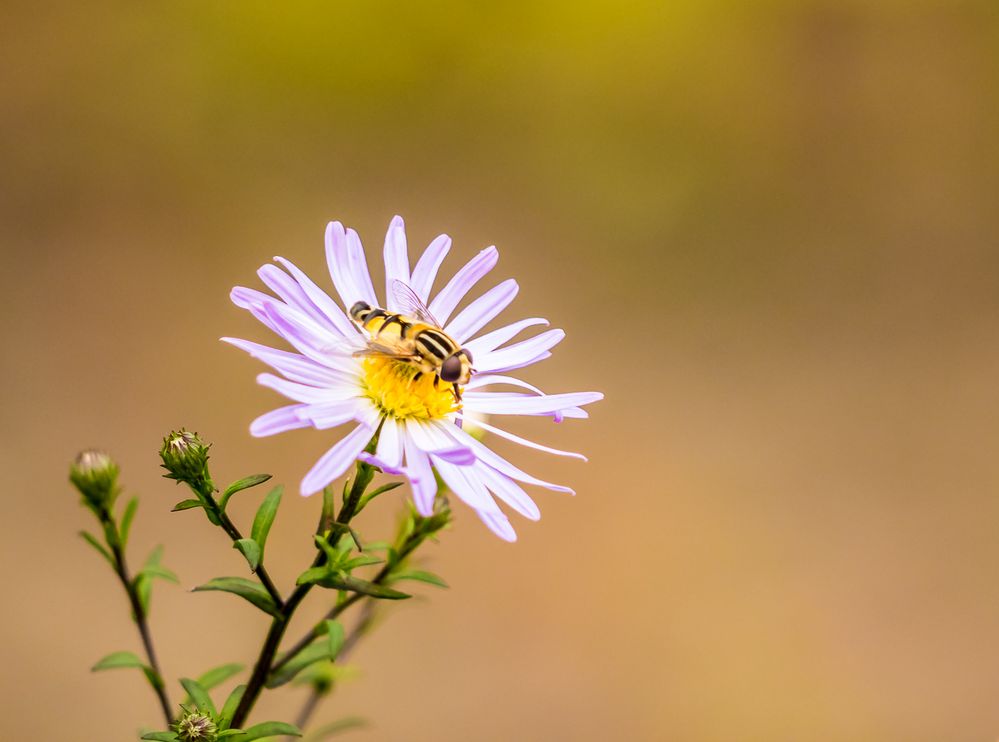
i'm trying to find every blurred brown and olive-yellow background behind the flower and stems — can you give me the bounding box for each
[0,0,999,742]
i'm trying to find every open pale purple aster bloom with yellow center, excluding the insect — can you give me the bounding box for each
[222,216,603,541]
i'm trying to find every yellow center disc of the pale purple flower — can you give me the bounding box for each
[363,356,458,420]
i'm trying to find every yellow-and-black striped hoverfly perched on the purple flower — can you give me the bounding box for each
[350,279,475,402]
